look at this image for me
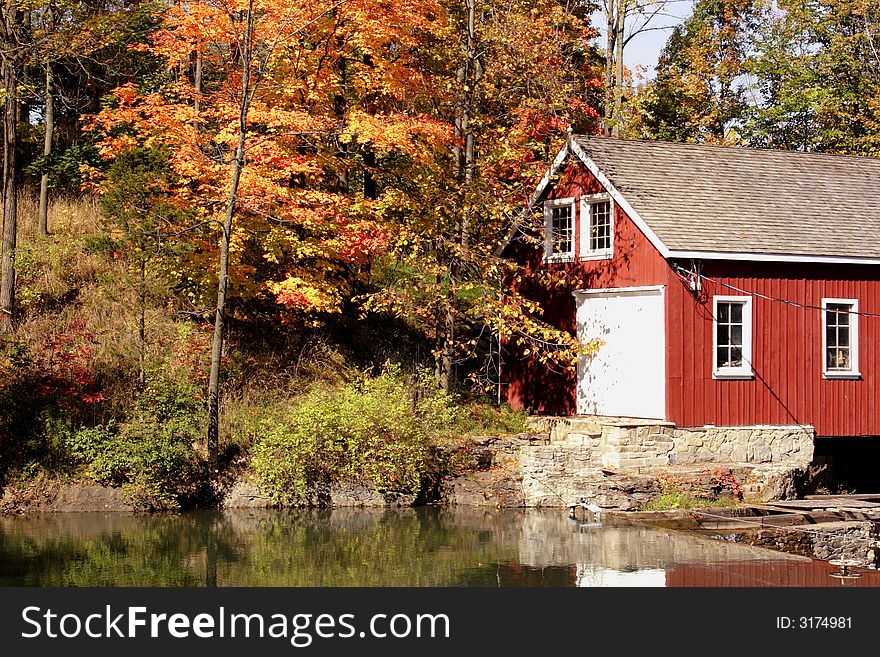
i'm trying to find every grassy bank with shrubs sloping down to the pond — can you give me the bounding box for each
[0,195,524,509]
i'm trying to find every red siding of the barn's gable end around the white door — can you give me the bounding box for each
[501,164,669,415]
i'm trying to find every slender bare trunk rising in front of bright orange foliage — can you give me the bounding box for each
[208,0,253,478]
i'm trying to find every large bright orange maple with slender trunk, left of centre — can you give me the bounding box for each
[95,0,451,466]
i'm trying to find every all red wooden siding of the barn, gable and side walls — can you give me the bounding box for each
[502,156,880,436]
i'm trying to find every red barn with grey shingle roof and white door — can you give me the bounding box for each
[504,135,880,436]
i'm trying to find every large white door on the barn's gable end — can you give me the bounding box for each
[575,286,666,419]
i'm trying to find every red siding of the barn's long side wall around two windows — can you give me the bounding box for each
[666,261,880,436]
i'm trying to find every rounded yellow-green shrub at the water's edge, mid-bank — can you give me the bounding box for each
[252,367,458,504]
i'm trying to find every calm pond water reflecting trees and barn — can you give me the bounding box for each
[0,507,880,587]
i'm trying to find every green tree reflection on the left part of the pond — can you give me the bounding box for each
[0,509,519,587]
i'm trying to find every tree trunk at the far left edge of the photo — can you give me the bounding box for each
[0,54,18,333]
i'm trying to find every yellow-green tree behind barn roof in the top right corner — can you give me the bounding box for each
[745,0,880,154]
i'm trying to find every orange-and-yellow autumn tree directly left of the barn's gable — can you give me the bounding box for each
[367,0,602,388]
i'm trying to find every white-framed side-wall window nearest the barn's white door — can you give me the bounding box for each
[712,296,752,379]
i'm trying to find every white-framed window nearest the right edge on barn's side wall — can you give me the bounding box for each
[822,299,859,378]
